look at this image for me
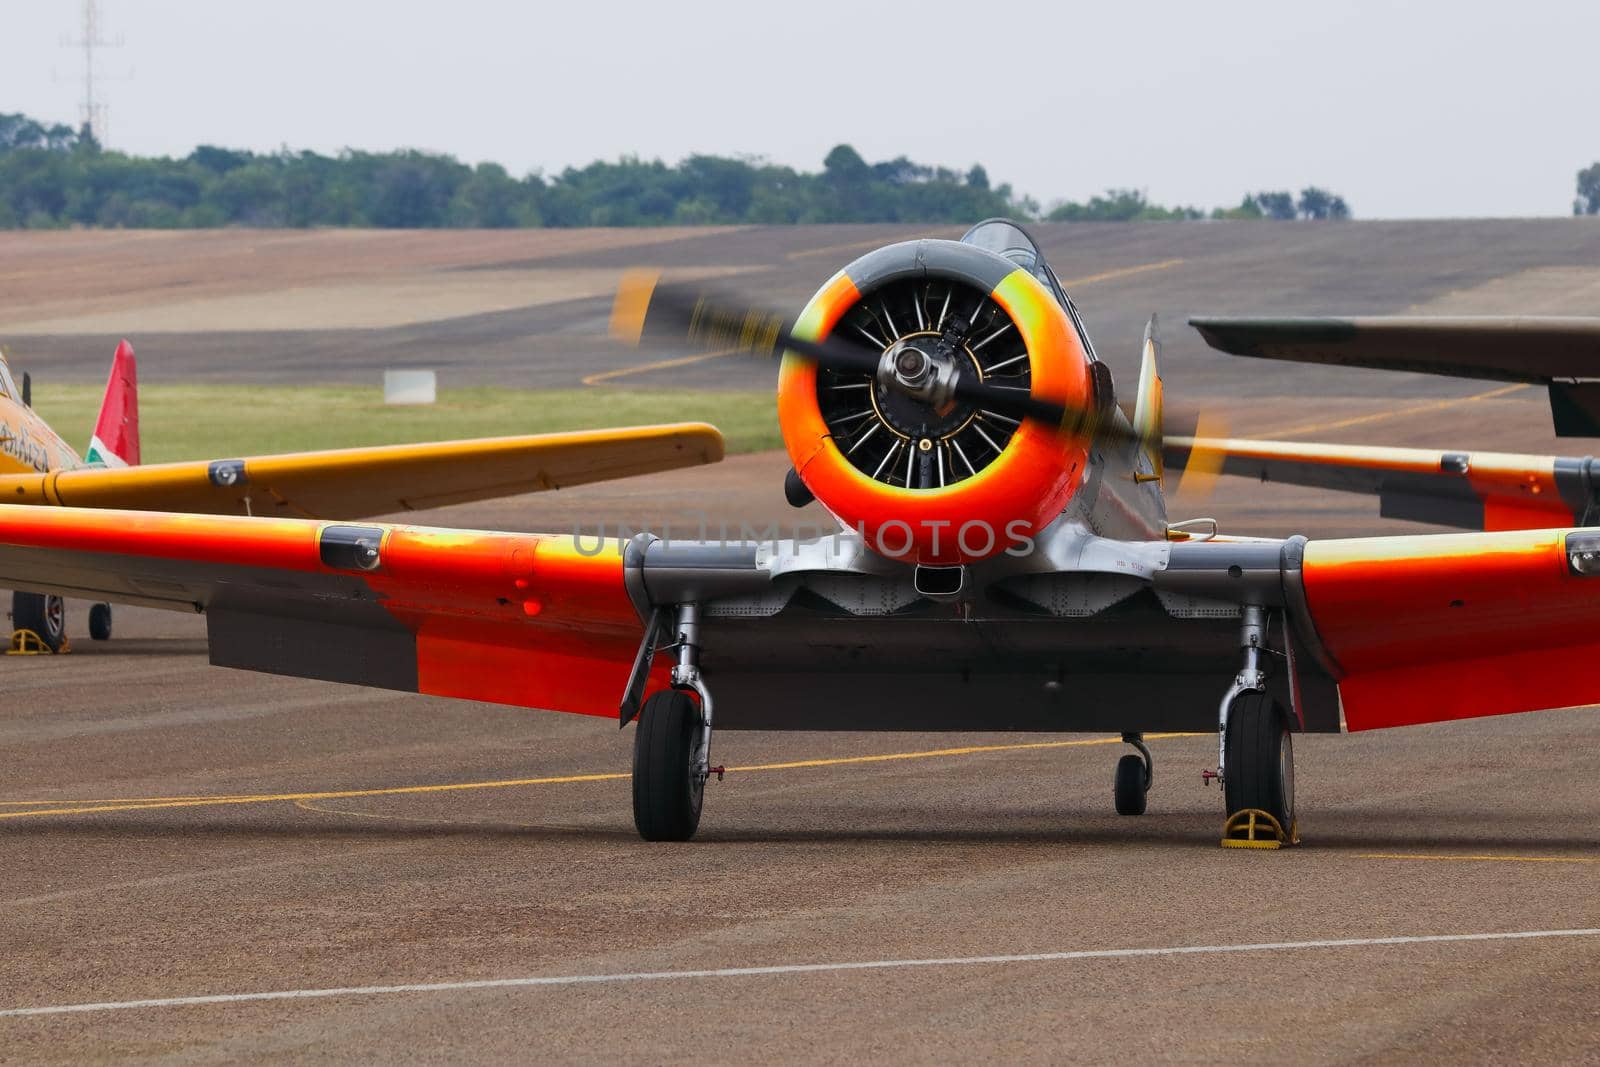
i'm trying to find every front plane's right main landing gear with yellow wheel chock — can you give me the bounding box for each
[1214,605,1299,848]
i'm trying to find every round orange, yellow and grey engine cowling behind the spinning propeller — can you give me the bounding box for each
[778,240,1093,566]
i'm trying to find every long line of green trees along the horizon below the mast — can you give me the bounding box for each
[0,115,1350,229]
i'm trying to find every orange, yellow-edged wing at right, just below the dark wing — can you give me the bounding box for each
[1165,437,1600,530]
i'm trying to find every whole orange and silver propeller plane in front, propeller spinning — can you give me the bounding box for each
[0,219,1600,848]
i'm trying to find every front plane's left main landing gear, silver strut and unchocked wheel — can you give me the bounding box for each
[634,605,722,841]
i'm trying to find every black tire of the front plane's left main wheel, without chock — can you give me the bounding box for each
[634,689,706,841]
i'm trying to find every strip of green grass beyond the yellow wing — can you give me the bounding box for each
[34,384,782,462]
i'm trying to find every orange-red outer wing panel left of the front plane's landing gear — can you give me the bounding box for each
[0,506,662,715]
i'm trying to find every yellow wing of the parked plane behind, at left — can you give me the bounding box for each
[0,422,723,518]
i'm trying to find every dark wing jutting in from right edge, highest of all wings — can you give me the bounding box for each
[1189,315,1600,437]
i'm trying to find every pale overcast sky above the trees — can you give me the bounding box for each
[0,0,1600,218]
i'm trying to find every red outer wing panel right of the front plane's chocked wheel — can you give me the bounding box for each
[1302,530,1600,729]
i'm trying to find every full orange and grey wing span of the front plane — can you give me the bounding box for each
[0,506,1600,731]
